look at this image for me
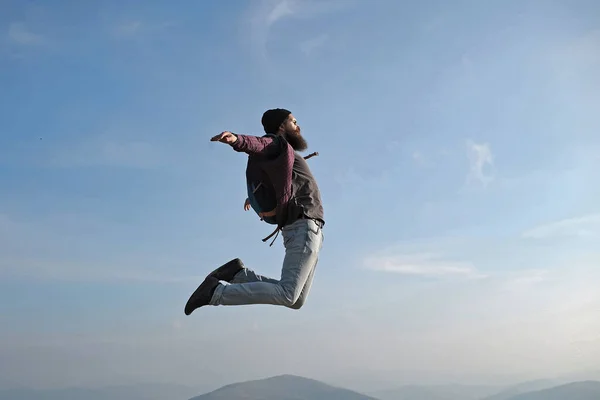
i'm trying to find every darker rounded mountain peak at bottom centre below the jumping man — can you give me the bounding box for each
[190,375,378,400]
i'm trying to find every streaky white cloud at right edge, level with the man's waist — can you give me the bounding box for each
[521,213,600,239]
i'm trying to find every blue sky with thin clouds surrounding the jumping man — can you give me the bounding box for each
[0,0,600,394]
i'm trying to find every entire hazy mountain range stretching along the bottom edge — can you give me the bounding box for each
[0,375,600,400]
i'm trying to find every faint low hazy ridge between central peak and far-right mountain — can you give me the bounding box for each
[370,385,501,400]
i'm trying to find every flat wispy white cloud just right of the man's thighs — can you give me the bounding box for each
[364,253,485,278]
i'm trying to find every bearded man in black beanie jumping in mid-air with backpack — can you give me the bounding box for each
[185,108,325,315]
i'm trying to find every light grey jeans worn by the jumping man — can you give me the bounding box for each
[210,219,323,309]
